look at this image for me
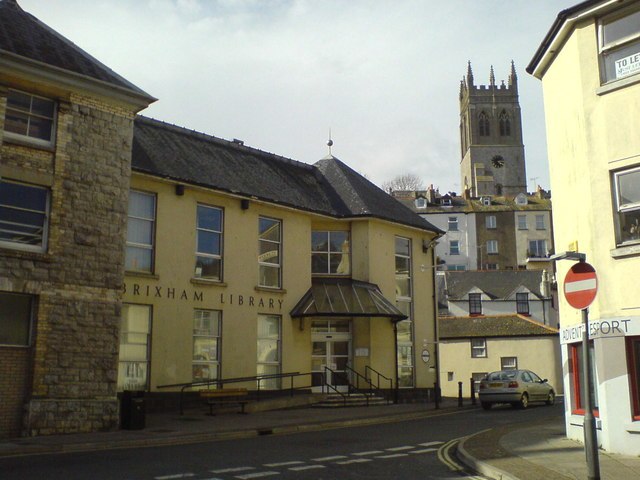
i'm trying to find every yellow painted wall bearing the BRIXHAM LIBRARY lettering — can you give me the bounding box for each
[124,173,435,390]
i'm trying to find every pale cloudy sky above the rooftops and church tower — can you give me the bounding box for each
[18,0,564,193]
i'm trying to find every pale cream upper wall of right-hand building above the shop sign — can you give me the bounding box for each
[542,22,640,326]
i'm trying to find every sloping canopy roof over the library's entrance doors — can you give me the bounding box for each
[290,278,408,322]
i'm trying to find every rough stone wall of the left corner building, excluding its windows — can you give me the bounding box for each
[0,88,133,436]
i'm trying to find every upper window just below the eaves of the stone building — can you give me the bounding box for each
[4,90,55,146]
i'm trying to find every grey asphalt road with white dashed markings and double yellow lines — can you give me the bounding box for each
[0,405,563,480]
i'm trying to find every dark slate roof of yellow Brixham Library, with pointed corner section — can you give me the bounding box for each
[132,116,440,232]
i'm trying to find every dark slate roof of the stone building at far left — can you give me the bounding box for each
[0,0,152,99]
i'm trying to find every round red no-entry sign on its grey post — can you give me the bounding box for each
[564,259,600,480]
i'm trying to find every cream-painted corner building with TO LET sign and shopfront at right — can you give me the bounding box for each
[527,0,640,455]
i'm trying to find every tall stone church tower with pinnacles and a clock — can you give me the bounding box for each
[460,62,527,197]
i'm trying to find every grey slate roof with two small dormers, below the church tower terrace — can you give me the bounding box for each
[445,270,543,300]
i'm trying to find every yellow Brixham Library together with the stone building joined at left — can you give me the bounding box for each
[0,0,441,437]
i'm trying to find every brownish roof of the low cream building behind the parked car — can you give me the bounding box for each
[438,315,558,340]
